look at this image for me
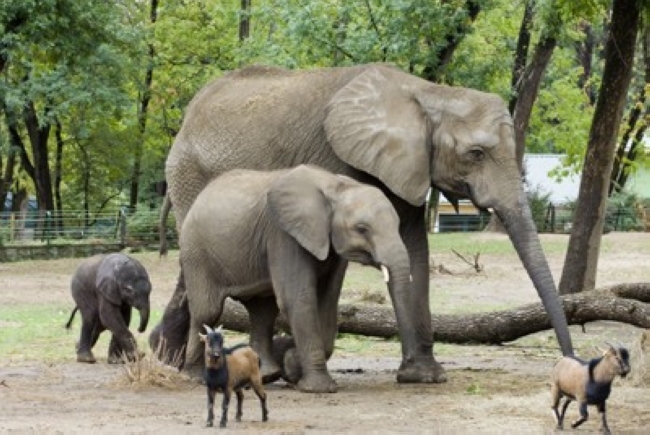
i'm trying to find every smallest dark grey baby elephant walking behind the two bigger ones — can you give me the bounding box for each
[65,253,151,364]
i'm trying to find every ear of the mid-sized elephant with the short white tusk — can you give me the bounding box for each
[267,165,333,261]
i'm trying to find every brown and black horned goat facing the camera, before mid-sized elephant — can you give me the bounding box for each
[199,325,269,427]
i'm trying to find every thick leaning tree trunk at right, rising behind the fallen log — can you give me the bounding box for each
[559,0,641,294]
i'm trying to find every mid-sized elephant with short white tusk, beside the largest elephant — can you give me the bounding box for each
[180,165,411,392]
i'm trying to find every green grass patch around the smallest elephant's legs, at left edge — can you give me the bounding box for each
[0,303,162,363]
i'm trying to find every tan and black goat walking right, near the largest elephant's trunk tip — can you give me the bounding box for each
[551,345,630,434]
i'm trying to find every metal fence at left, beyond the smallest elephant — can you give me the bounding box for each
[0,209,175,246]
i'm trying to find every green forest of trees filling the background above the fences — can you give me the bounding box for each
[0,0,650,287]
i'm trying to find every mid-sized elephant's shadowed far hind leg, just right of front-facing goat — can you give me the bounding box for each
[243,296,280,383]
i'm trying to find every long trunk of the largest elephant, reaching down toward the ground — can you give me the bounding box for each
[495,190,573,355]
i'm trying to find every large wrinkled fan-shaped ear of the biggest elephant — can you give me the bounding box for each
[325,66,432,205]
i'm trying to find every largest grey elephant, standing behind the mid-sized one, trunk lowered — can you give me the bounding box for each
[154,64,573,382]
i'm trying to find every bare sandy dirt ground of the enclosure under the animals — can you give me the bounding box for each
[0,233,650,434]
